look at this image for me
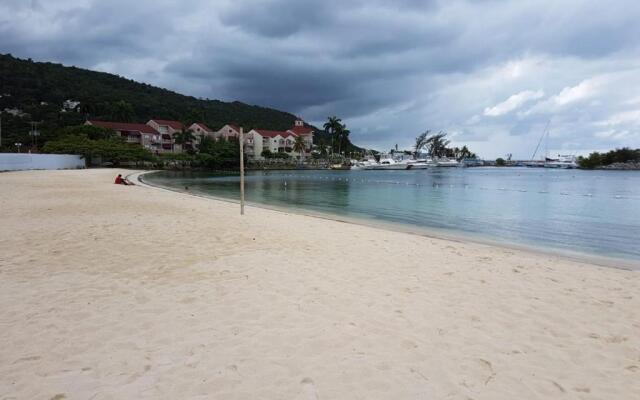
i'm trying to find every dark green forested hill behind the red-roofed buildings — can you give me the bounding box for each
[0,54,350,149]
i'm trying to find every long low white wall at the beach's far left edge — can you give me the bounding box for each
[0,153,85,171]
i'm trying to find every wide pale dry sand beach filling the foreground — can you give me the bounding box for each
[0,170,640,400]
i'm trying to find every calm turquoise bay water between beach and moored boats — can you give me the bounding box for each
[144,168,640,261]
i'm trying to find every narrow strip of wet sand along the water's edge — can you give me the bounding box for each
[132,170,640,271]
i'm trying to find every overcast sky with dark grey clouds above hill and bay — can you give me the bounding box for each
[0,0,640,158]
